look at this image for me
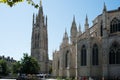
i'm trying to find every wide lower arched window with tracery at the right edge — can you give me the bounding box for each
[109,42,120,64]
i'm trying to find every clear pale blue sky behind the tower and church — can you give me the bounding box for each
[0,0,120,60]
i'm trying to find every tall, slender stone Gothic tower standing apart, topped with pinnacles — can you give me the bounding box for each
[31,3,49,73]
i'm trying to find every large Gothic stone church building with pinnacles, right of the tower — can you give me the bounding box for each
[53,4,120,79]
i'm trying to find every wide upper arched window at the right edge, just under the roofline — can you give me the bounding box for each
[110,18,120,33]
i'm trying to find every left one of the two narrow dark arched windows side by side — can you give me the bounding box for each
[81,45,87,66]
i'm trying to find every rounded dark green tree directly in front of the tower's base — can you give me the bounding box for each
[20,54,40,74]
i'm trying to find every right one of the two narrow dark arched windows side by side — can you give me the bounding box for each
[92,44,99,65]
